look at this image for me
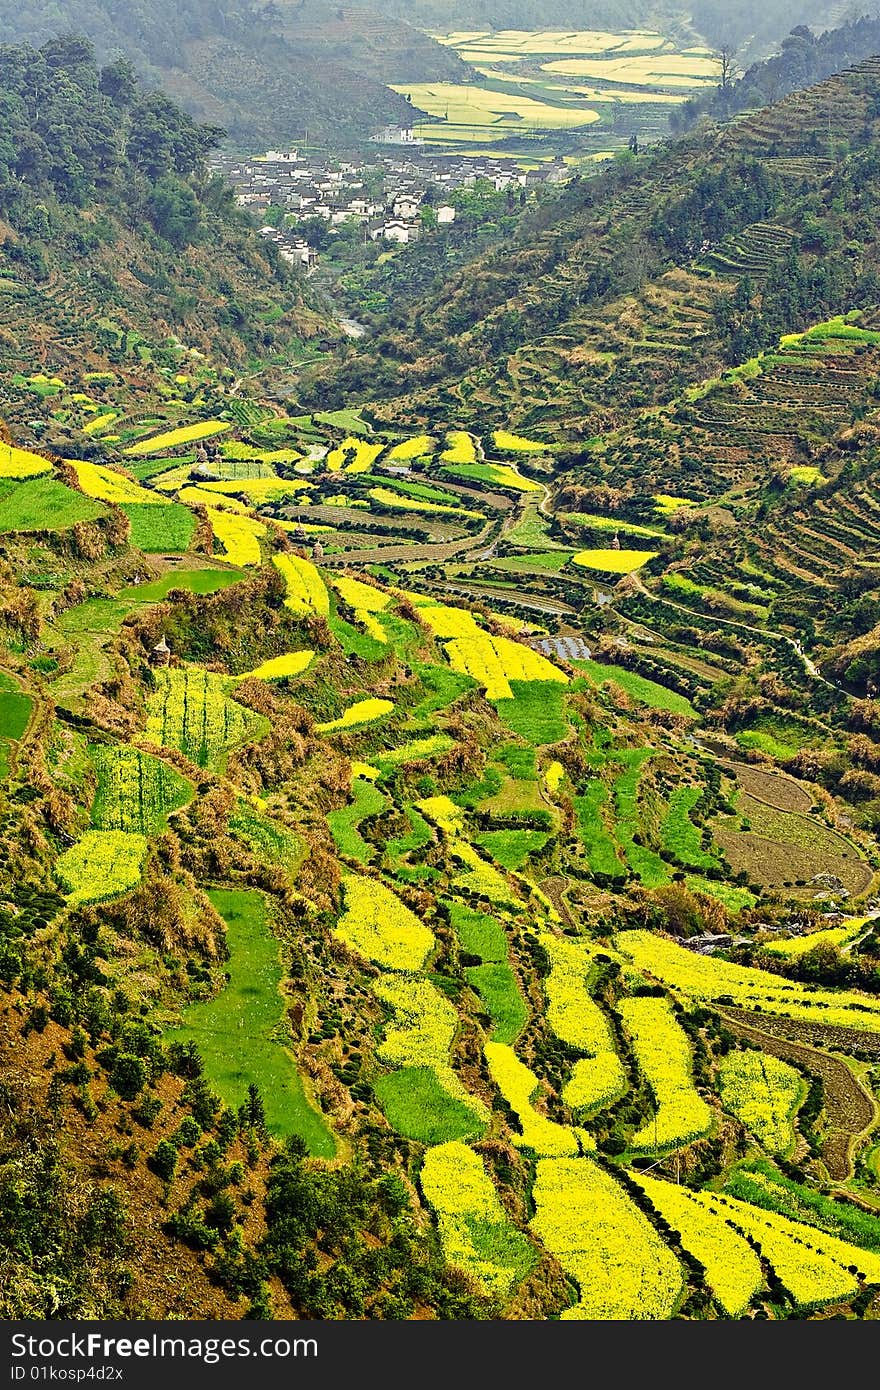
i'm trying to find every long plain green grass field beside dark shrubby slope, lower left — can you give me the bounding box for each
[165,888,336,1158]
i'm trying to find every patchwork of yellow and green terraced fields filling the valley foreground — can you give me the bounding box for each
[0,284,880,1319]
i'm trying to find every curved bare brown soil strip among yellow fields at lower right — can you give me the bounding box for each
[722,1009,876,1183]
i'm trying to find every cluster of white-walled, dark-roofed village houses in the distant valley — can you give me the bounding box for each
[214,131,570,270]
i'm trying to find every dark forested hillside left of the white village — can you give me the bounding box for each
[0,38,324,386]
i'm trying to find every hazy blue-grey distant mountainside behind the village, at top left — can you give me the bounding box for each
[0,0,433,145]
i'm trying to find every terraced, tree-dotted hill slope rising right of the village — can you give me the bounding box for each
[308,60,880,434]
